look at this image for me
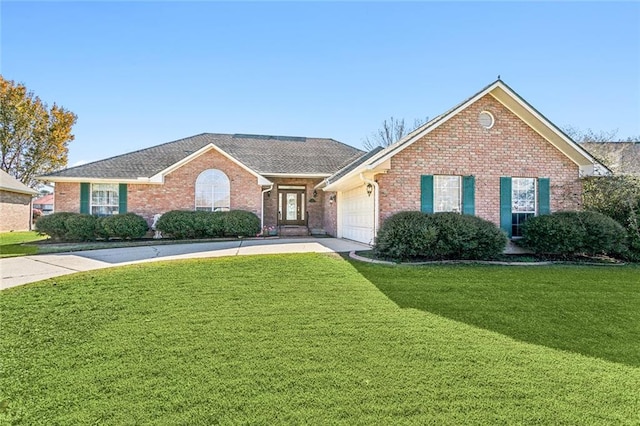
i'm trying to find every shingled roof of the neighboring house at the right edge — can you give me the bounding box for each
[580,142,640,176]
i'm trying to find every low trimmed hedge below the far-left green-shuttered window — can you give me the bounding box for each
[36,213,149,241]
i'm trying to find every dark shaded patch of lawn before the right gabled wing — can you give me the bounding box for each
[350,260,640,367]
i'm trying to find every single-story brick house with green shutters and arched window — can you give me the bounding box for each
[41,80,609,243]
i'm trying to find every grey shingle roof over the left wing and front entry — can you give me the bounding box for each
[42,133,364,179]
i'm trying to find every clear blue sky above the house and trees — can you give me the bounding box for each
[0,0,640,165]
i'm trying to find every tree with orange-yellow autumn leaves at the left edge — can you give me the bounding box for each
[0,75,77,186]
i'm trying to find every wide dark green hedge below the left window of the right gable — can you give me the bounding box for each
[374,211,507,260]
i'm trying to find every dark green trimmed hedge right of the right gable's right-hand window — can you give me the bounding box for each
[520,211,628,256]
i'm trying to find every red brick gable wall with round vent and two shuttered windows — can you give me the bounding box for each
[376,95,582,225]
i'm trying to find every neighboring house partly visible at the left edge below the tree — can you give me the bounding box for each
[0,170,38,232]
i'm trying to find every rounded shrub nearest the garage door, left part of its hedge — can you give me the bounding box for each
[373,211,438,260]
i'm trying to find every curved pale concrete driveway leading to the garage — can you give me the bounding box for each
[0,238,370,290]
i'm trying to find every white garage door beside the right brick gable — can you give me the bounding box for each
[338,186,375,244]
